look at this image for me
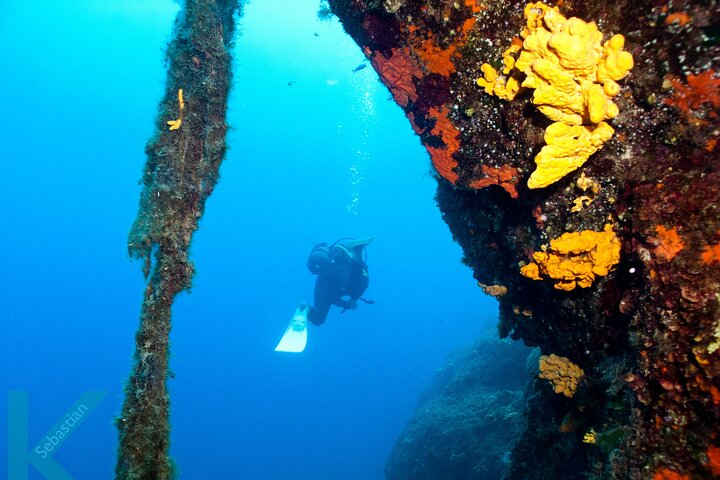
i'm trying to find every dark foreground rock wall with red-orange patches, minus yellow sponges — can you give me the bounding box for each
[329,0,720,479]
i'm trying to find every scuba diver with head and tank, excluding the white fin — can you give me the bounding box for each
[298,237,375,325]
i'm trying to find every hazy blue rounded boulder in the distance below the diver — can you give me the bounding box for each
[385,341,529,480]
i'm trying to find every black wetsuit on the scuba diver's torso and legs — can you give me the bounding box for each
[308,245,370,325]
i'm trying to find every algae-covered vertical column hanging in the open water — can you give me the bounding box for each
[115,0,240,479]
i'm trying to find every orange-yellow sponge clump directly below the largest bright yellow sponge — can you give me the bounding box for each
[520,224,620,291]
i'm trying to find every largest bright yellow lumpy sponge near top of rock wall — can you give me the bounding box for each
[477,2,633,188]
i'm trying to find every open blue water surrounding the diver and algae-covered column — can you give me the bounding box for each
[0,0,496,480]
